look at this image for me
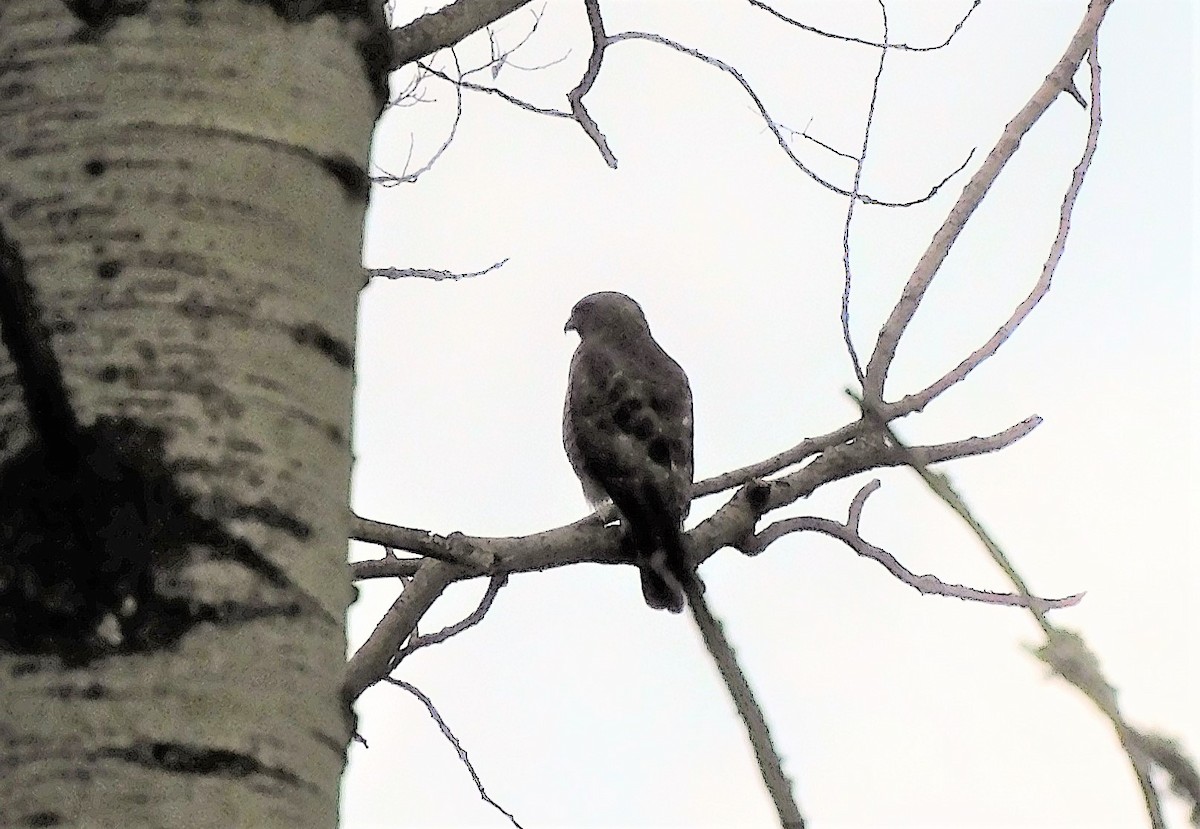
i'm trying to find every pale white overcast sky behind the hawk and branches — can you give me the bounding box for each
[343,0,1200,829]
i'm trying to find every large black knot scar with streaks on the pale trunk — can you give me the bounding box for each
[0,228,312,665]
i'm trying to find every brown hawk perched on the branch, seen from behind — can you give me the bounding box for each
[563,292,696,613]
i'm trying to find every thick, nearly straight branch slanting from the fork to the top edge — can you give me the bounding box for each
[864,0,1112,404]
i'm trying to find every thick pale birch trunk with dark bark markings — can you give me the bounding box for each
[0,0,389,828]
